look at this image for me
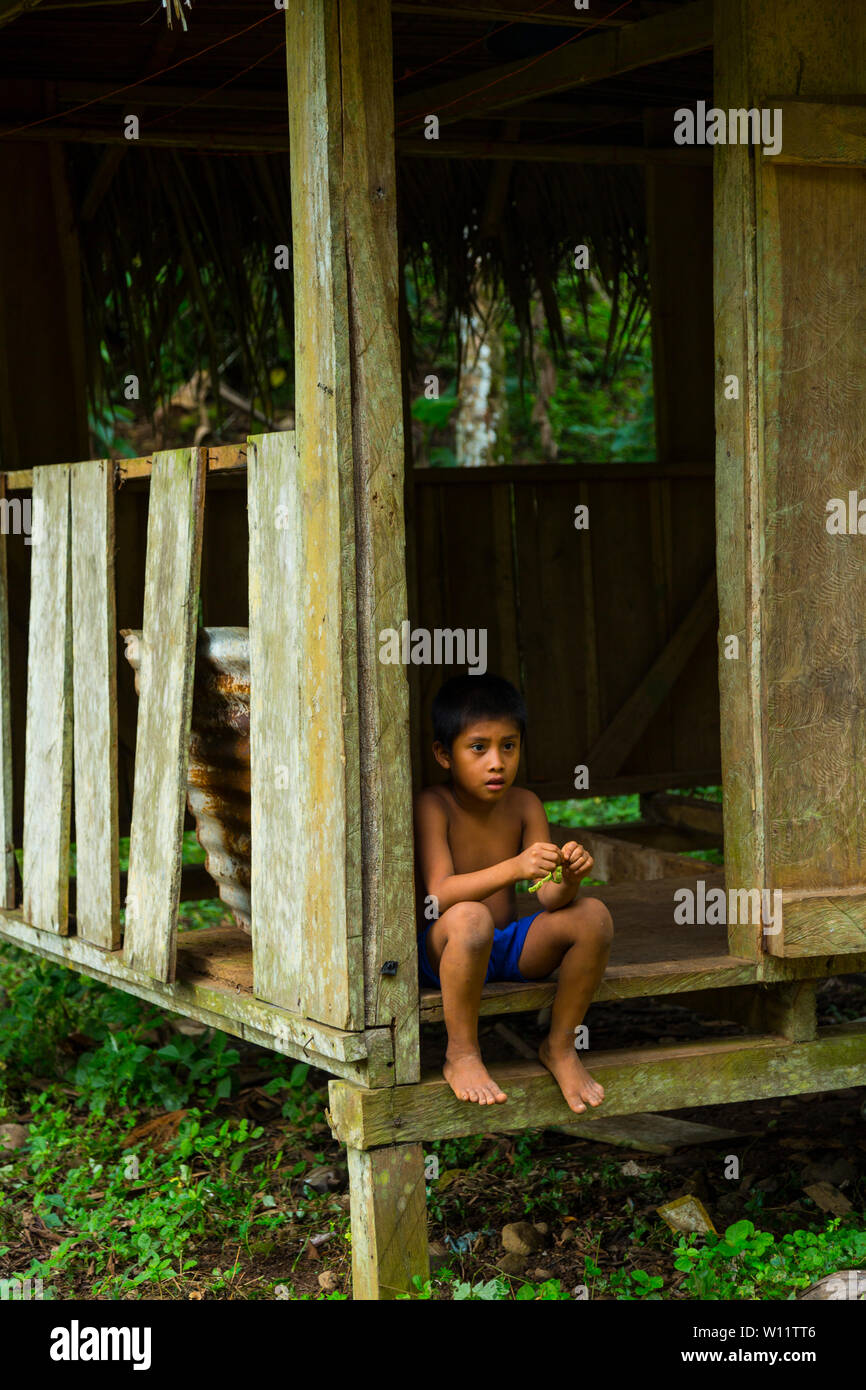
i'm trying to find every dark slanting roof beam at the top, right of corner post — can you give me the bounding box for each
[398,0,713,129]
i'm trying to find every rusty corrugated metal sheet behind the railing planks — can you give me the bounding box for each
[121,627,252,931]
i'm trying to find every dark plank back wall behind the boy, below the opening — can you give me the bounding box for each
[410,464,719,796]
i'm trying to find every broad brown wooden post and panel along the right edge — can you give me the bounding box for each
[714,0,866,956]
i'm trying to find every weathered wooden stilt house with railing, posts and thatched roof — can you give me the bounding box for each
[0,0,866,1298]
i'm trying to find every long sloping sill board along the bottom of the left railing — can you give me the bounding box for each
[0,912,393,1086]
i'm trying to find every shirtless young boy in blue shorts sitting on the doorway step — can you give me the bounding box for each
[416,676,613,1113]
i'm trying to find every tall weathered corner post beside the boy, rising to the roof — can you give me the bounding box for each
[286,0,418,1061]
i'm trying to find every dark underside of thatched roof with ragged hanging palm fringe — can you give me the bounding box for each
[0,0,712,403]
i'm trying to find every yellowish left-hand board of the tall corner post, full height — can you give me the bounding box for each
[286,0,364,1027]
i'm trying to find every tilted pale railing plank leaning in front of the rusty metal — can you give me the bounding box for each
[124,449,204,980]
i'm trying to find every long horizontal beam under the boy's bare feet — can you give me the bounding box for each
[328,1023,866,1148]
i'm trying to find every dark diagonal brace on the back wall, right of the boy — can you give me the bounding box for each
[585,575,717,785]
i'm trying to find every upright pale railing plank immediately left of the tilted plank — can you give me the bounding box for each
[70,459,120,951]
